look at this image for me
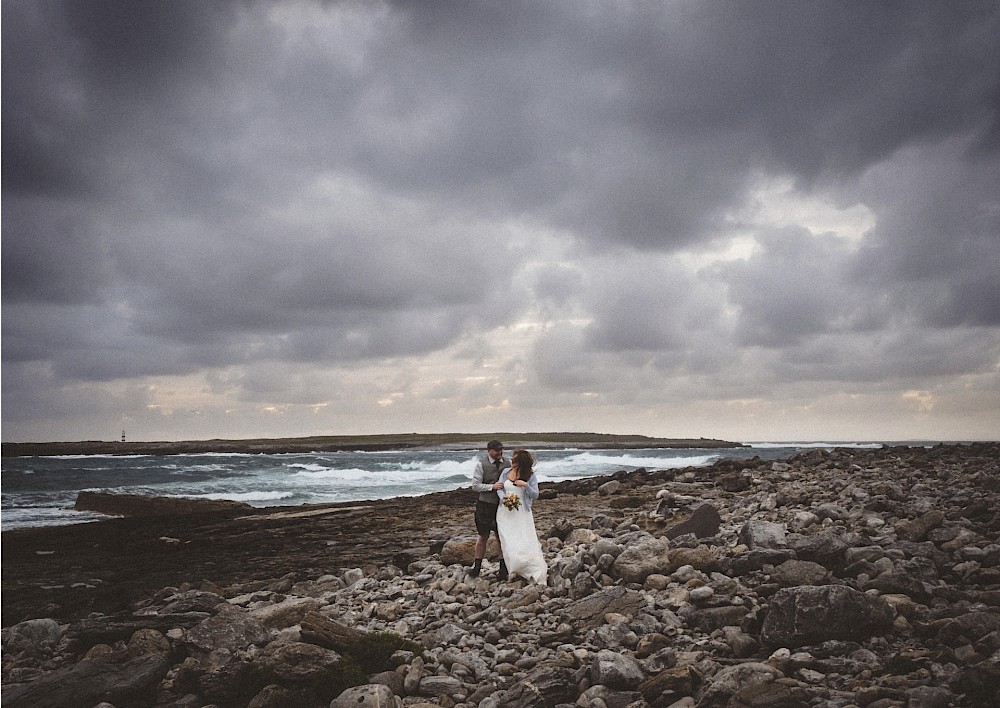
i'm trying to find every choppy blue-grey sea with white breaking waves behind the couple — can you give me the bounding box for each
[0,442,879,531]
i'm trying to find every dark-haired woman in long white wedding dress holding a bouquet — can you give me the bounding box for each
[497,450,548,585]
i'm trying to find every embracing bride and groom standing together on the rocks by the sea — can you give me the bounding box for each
[469,440,548,585]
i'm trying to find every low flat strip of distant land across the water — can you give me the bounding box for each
[0,433,746,457]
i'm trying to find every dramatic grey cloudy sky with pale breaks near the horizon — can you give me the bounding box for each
[2,0,1000,441]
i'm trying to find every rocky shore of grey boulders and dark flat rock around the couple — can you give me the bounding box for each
[2,443,1000,708]
